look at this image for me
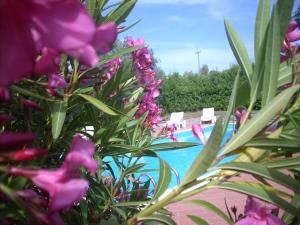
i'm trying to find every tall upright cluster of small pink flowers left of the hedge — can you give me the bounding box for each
[126,37,161,127]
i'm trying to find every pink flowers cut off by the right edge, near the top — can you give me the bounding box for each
[280,20,300,62]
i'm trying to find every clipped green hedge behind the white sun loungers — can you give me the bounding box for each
[159,66,245,113]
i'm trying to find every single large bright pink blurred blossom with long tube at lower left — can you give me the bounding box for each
[9,135,98,213]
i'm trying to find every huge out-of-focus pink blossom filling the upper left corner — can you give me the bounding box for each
[0,0,117,100]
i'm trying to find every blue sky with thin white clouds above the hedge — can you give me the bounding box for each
[119,0,300,74]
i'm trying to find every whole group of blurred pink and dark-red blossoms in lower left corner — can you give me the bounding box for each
[0,132,98,225]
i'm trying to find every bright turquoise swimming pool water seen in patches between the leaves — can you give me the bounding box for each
[105,124,234,187]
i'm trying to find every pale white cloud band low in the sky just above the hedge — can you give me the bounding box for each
[154,44,236,74]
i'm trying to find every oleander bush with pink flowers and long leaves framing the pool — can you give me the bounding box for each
[0,0,300,225]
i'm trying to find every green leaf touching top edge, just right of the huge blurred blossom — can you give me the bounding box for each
[105,0,136,25]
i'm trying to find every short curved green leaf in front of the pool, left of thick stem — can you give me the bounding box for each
[152,159,171,200]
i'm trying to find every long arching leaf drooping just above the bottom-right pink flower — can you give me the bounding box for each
[208,182,300,215]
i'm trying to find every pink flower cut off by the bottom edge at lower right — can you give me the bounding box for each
[235,196,285,225]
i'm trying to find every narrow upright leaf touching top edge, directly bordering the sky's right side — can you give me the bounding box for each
[254,0,270,61]
